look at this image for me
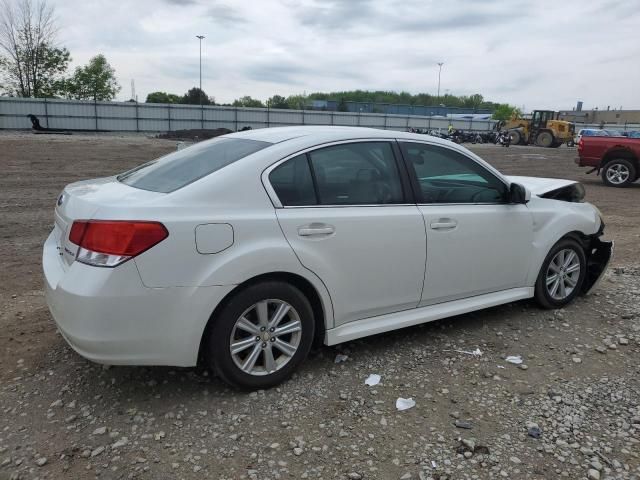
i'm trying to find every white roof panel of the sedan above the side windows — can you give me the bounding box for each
[225,125,451,145]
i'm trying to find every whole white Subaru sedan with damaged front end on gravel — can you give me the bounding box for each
[42,127,612,388]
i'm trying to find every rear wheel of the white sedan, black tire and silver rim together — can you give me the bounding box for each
[206,281,315,390]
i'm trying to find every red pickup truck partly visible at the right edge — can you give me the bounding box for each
[576,136,640,187]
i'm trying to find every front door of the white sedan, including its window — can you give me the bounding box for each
[401,142,533,306]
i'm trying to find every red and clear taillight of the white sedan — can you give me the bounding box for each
[69,220,169,267]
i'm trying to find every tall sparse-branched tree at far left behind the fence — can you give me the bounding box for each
[0,0,71,97]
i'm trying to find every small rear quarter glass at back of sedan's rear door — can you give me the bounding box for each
[269,154,318,207]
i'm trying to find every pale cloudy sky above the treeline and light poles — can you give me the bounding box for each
[49,0,640,110]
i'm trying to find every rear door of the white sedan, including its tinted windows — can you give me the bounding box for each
[267,140,426,326]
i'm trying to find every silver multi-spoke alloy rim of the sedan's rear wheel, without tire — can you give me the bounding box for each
[229,299,302,376]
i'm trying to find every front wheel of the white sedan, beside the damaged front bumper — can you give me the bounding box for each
[535,238,587,309]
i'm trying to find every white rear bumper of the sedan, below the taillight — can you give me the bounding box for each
[42,234,233,366]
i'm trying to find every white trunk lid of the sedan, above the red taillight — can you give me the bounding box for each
[53,177,166,269]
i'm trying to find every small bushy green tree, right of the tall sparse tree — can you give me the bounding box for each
[65,54,120,101]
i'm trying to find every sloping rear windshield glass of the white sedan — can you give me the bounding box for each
[117,138,271,193]
